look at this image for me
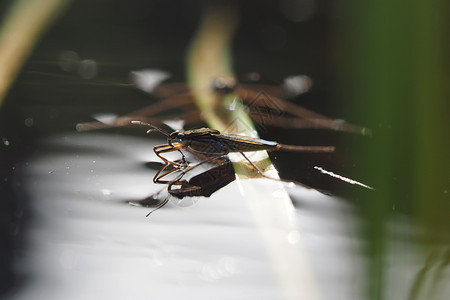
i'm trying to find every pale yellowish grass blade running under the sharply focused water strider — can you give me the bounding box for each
[188,5,319,300]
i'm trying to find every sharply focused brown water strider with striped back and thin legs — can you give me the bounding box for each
[131,121,335,211]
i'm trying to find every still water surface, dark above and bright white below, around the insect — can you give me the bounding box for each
[0,0,449,299]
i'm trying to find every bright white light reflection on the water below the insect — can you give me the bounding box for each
[8,132,448,300]
